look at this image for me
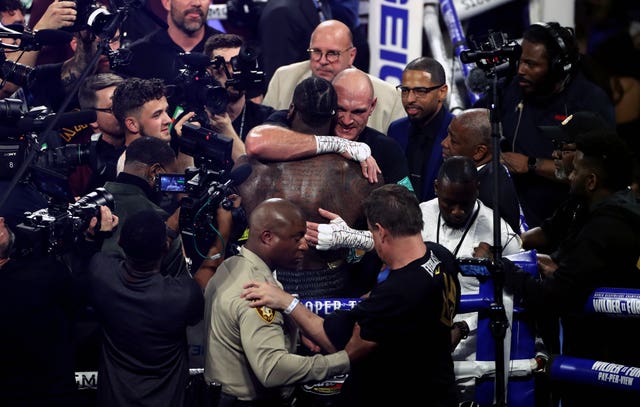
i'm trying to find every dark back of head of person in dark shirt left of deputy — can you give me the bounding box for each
[118,209,168,263]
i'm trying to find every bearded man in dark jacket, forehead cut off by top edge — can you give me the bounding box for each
[119,0,220,84]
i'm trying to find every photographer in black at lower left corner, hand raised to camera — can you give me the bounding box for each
[0,206,118,407]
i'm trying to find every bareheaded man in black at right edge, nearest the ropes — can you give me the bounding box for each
[505,128,640,407]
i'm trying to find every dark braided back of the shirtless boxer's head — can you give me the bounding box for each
[291,76,338,127]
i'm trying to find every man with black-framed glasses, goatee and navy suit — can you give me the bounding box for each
[387,57,453,202]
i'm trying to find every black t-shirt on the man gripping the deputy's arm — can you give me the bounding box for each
[324,242,460,407]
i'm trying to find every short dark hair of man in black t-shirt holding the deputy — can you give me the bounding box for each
[362,184,424,237]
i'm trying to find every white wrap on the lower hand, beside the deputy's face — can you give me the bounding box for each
[316,218,373,251]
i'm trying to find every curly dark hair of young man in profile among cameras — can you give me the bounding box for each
[113,78,166,128]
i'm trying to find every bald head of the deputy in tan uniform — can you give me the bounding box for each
[245,198,308,269]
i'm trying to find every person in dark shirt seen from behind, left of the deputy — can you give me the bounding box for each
[89,209,204,407]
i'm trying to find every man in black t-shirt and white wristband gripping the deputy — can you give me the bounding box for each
[241,184,460,407]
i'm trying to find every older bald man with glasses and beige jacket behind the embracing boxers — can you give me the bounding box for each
[263,20,405,134]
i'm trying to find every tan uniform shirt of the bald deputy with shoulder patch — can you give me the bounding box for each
[204,247,349,400]
